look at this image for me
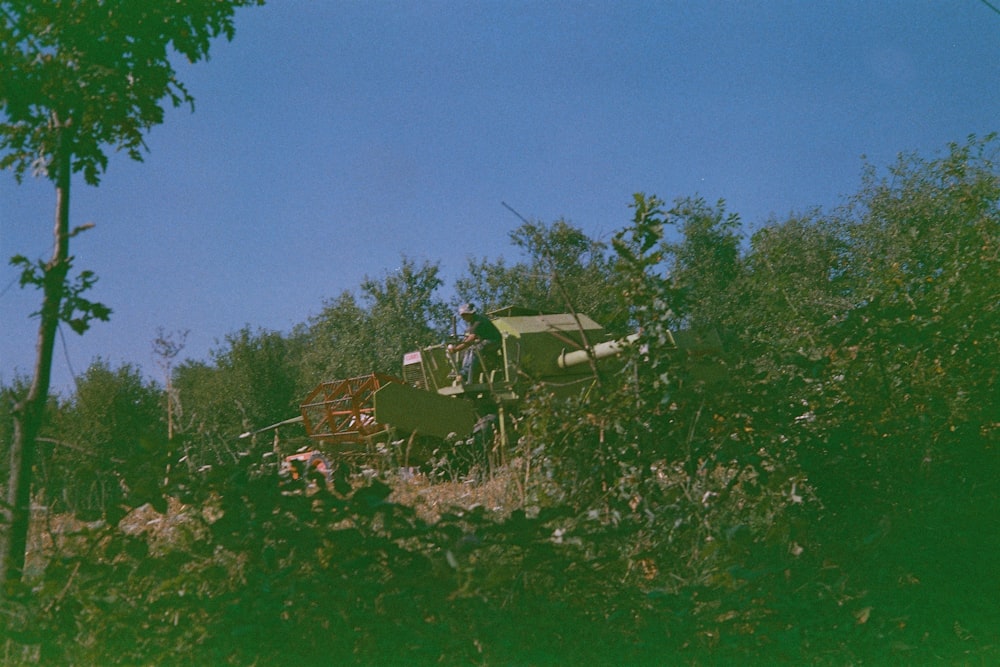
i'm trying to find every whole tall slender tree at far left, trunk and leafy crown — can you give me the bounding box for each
[0,0,260,581]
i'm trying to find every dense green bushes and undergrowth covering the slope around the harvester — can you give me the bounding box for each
[0,137,1000,665]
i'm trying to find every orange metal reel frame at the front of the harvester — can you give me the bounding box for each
[299,373,403,444]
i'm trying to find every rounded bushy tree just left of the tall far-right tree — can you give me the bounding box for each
[713,212,852,454]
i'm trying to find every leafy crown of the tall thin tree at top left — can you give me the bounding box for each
[0,0,261,185]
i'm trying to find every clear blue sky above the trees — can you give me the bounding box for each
[0,0,1000,392]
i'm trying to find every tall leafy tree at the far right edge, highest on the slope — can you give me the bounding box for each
[833,135,1000,484]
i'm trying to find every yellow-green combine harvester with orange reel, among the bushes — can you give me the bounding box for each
[243,307,720,469]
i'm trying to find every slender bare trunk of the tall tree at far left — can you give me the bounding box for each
[0,142,72,584]
